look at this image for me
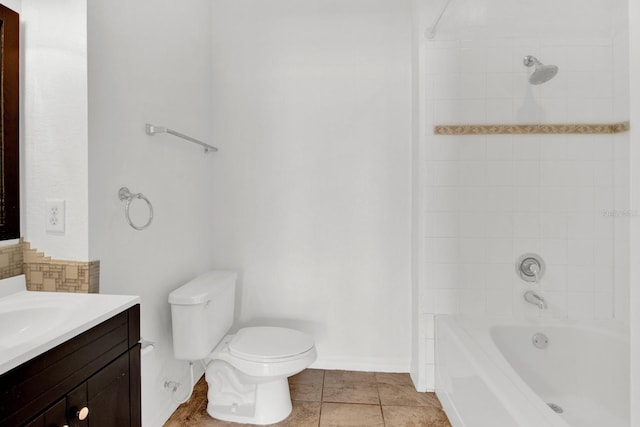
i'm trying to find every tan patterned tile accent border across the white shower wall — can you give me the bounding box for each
[433,122,630,135]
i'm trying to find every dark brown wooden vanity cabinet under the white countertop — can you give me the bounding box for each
[0,305,141,427]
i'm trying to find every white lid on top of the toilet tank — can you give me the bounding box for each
[169,270,238,305]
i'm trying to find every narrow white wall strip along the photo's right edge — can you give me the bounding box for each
[629,0,640,427]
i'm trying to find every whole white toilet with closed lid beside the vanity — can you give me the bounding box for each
[169,271,317,425]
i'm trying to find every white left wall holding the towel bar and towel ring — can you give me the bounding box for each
[88,0,216,426]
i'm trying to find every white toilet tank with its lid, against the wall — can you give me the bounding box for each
[169,271,238,360]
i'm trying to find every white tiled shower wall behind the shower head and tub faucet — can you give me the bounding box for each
[421,37,634,388]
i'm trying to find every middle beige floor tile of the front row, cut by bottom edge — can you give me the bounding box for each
[320,403,384,427]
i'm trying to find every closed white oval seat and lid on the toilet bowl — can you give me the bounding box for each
[229,326,314,363]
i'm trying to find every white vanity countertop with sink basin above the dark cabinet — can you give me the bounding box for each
[0,290,140,374]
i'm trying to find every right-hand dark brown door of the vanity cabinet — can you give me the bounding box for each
[87,352,131,427]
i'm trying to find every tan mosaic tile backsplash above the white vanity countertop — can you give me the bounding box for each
[0,240,100,293]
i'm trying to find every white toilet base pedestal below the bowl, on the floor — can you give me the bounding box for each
[206,361,292,425]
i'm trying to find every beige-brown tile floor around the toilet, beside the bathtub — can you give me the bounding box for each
[165,369,451,427]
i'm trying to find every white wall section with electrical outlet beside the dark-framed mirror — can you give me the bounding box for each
[21,0,89,261]
